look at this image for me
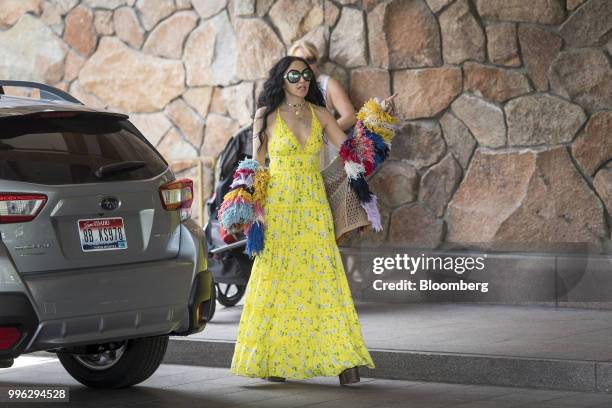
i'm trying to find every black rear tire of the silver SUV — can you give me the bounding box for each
[57,335,168,388]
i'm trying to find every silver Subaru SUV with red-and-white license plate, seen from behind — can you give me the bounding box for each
[0,81,214,388]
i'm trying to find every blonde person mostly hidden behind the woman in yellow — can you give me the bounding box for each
[289,40,356,170]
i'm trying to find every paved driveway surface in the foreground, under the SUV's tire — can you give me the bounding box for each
[0,354,612,408]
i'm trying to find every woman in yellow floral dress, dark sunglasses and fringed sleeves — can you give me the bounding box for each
[219,57,400,385]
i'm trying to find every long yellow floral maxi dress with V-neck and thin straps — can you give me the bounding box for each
[230,106,374,379]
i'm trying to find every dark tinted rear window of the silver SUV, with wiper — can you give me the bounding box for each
[0,115,168,185]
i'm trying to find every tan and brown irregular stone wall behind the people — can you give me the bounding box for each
[0,0,612,251]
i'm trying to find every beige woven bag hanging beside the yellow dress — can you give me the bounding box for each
[321,156,370,242]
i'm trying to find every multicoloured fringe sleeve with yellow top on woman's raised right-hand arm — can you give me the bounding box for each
[339,99,399,231]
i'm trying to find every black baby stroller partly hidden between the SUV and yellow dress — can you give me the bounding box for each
[204,125,268,318]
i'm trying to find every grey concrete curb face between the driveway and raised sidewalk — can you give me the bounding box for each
[163,338,612,393]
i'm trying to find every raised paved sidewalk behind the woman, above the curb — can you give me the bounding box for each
[200,302,612,361]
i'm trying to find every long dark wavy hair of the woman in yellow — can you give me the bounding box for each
[256,56,325,150]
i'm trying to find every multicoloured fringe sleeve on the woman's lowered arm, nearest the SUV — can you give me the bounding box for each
[217,159,270,258]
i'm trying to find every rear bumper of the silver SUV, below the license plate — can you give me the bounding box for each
[0,220,213,359]
